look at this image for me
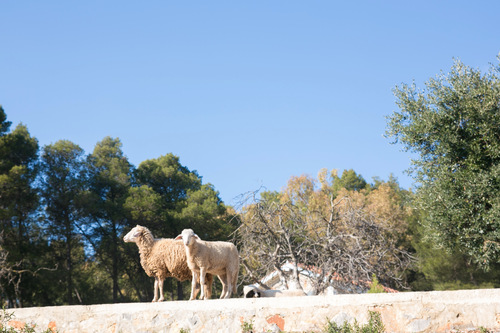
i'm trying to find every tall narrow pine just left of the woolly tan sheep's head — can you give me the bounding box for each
[82,137,133,302]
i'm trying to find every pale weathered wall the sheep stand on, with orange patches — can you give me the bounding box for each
[3,289,500,333]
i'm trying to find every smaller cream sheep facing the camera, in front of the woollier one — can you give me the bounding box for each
[175,229,240,300]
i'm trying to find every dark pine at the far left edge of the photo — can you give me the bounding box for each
[0,106,42,306]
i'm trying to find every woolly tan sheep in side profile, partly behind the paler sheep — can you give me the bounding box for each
[123,225,213,302]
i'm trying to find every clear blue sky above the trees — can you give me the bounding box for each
[0,0,500,204]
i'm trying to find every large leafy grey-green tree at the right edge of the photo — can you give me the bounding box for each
[386,57,500,270]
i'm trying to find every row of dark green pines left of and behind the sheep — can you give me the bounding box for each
[0,108,237,307]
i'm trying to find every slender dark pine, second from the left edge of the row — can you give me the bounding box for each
[41,140,86,304]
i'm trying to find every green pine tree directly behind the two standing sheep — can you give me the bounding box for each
[125,154,235,299]
